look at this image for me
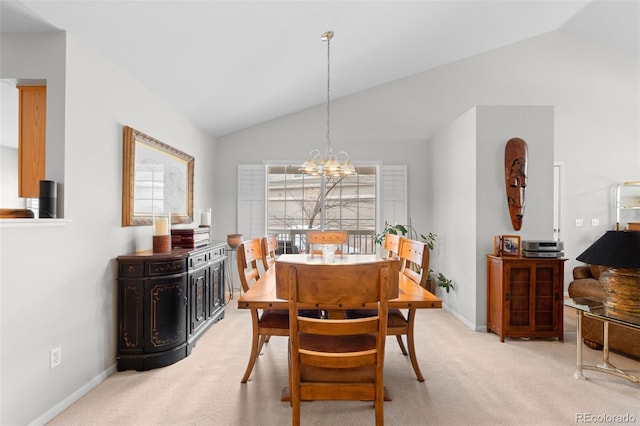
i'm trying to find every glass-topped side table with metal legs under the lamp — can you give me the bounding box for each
[564,297,640,384]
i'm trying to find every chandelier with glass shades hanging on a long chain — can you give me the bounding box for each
[300,31,356,177]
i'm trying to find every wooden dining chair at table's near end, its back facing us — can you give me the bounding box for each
[285,259,400,426]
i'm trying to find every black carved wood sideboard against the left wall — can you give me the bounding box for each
[117,242,227,371]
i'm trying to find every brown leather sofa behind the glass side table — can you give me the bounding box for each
[568,265,640,359]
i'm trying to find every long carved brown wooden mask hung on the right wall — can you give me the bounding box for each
[504,138,527,231]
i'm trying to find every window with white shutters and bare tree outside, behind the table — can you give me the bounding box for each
[237,163,408,253]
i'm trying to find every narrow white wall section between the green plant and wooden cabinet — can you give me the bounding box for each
[424,108,478,327]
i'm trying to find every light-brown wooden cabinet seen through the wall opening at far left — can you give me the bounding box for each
[18,86,47,198]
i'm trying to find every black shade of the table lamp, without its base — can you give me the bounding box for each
[576,231,640,269]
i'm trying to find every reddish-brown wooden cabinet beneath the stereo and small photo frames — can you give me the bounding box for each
[487,255,566,342]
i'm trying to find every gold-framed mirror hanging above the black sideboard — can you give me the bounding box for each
[122,126,194,226]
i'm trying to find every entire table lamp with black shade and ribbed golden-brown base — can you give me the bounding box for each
[576,231,640,323]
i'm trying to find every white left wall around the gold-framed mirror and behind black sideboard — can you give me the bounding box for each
[0,33,215,425]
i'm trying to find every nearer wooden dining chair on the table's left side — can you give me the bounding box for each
[237,238,289,383]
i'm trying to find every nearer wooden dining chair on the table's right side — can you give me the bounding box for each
[347,238,429,382]
